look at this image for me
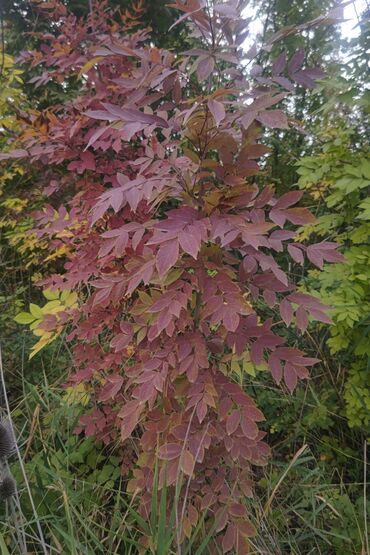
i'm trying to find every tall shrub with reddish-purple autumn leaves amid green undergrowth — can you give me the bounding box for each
[4,0,339,553]
